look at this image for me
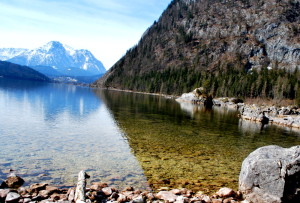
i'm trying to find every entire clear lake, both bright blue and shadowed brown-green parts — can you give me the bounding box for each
[0,78,300,193]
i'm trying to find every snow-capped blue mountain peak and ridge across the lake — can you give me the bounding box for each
[0,41,106,76]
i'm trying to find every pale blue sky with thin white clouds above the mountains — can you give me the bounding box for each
[0,0,171,69]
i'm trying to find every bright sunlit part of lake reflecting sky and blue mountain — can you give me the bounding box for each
[0,79,147,189]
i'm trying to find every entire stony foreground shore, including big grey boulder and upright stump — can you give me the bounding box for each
[0,145,300,203]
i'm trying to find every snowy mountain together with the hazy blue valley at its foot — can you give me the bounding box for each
[0,41,106,83]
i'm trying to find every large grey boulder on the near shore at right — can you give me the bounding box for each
[239,145,300,203]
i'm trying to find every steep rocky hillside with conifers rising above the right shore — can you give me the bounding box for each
[94,0,300,99]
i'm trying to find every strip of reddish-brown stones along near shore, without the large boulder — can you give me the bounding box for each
[0,174,249,203]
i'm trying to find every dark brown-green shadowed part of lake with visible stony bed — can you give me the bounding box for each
[95,90,300,192]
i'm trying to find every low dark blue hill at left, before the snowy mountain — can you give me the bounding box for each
[0,61,50,82]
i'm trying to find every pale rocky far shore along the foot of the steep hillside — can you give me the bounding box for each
[91,87,300,130]
